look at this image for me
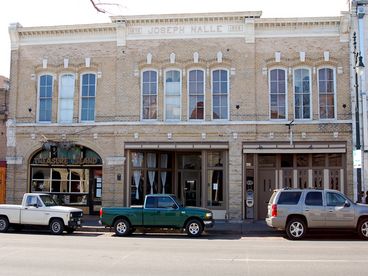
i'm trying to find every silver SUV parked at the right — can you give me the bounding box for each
[266,189,368,240]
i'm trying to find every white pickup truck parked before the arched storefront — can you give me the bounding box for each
[0,193,83,235]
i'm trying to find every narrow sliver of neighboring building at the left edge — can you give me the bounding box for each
[0,76,9,204]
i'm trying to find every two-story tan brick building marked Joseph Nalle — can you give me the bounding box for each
[7,12,353,220]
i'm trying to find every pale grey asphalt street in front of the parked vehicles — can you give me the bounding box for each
[0,232,368,276]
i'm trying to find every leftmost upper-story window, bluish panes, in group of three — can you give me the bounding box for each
[38,75,53,122]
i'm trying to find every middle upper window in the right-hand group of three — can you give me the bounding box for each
[294,69,311,119]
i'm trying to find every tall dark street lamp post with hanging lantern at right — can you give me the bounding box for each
[353,32,364,202]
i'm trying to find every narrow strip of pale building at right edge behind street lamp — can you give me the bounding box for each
[350,0,368,201]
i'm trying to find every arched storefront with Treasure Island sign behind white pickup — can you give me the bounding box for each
[29,143,102,214]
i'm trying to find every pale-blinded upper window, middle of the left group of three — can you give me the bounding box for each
[59,74,74,123]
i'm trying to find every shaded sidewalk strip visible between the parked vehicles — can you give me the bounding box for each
[80,215,280,236]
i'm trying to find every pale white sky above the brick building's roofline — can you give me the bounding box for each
[0,0,349,77]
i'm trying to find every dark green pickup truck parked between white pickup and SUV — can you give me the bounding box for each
[100,194,214,237]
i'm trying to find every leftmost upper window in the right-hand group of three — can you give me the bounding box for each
[269,69,286,119]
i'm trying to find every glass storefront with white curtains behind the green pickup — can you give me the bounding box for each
[127,145,228,218]
